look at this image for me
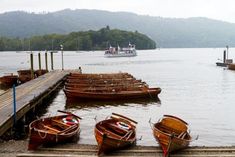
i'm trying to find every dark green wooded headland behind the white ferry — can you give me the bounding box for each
[0,26,156,51]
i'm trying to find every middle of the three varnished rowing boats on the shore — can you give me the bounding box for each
[94,113,137,155]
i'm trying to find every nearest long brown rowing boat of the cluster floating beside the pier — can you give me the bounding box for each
[64,88,161,100]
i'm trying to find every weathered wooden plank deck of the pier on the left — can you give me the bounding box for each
[0,70,70,136]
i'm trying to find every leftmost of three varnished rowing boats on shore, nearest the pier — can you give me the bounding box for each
[28,111,81,150]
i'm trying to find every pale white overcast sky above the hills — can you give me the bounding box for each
[0,0,235,23]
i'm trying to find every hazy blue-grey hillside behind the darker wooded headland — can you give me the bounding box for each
[0,9,235,47]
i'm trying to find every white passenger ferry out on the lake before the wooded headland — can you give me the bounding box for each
[104,43,137,58]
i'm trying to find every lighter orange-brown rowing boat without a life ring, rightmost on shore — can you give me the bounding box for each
[152,115,196,157]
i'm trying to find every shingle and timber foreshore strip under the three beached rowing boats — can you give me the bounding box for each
[0,140,235,157]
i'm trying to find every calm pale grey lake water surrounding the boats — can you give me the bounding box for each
[0,48,235,146]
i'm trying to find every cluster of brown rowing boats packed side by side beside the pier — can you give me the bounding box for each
[64,73,161,100]
